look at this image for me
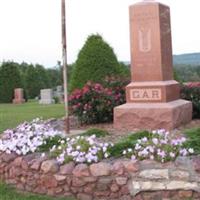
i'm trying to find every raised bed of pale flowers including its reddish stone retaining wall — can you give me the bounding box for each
[0,119,200,200]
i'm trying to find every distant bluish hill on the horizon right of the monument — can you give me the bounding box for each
[173,53,200,65]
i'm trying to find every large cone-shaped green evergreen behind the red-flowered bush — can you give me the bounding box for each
[70,34,124,91]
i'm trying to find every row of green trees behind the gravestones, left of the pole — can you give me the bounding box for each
[0,61,62,103]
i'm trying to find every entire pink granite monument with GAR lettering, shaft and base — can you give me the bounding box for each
[114,1,192,130]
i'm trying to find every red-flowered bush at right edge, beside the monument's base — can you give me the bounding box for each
[181,83,200,118]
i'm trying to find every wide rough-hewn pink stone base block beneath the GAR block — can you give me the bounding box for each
[114,99,192,131]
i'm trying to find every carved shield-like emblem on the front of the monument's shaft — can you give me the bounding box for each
[138,27,151,53]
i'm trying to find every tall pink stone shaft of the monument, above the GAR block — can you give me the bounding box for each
[129,2,173,81]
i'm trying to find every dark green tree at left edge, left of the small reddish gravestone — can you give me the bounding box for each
[0,62,22,103]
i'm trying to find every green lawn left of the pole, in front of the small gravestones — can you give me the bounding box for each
[0,101,64,133]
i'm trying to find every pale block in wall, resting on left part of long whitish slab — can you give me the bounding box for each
[139,169,169,179]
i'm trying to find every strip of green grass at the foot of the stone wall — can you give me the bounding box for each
[0,183,75,200]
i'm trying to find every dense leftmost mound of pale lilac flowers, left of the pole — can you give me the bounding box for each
[0,118,62,155]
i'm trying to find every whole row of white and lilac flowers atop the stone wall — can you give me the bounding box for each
[0,119,195,164]
